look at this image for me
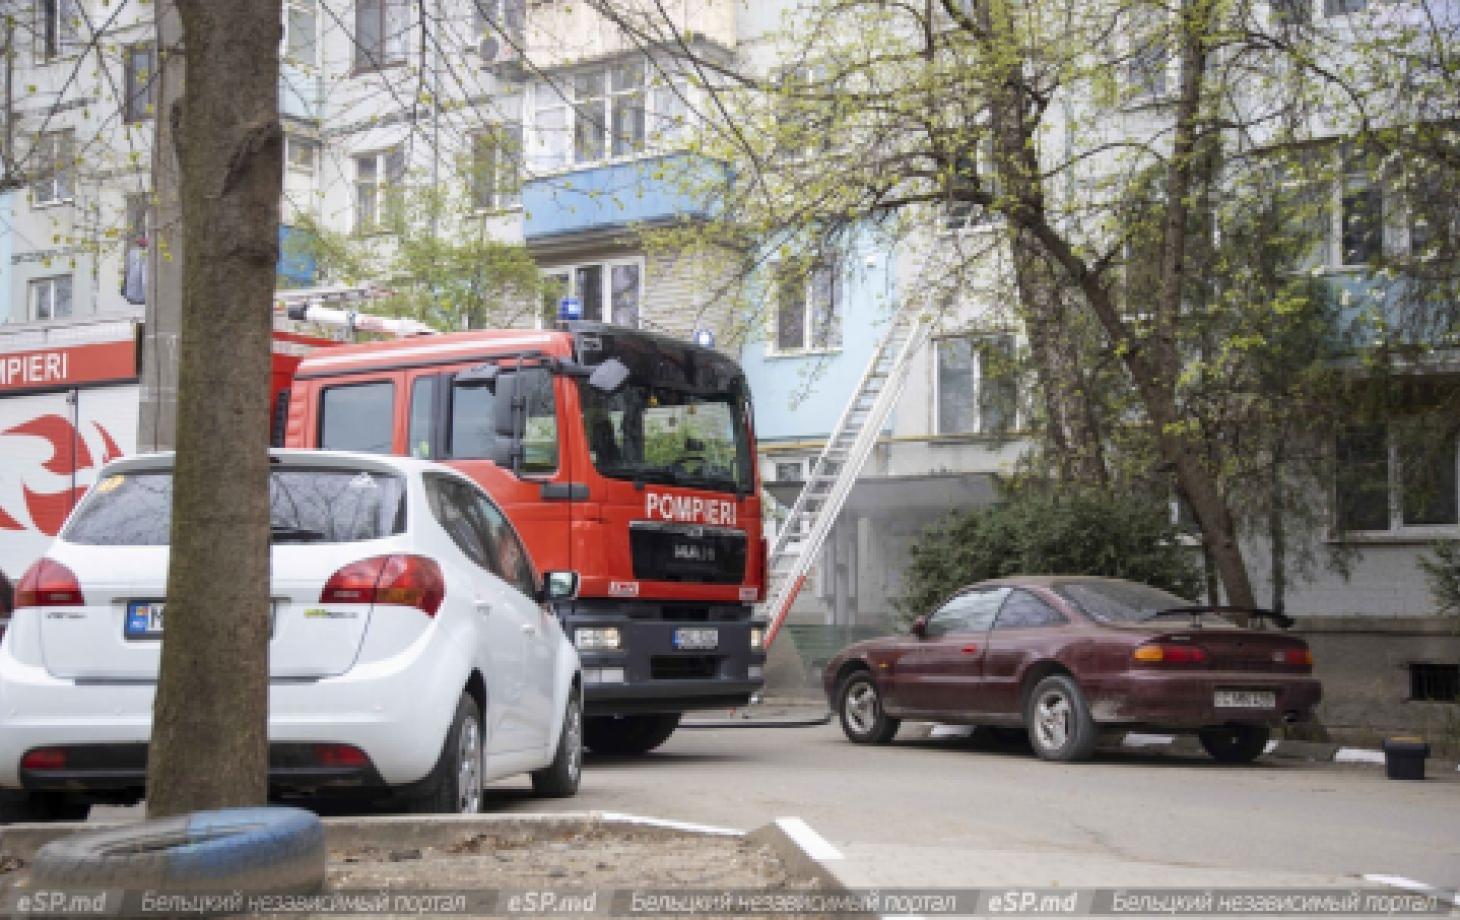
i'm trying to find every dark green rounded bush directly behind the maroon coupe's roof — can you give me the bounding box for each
[894,489,1202,619]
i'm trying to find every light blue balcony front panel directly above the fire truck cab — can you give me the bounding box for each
[523,153,724,242]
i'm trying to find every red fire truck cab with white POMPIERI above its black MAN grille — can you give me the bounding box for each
[280,321,765,754]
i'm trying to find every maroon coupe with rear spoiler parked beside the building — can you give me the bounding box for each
[822,575,1323,762]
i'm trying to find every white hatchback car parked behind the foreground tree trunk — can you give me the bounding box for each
[0,450,583,821]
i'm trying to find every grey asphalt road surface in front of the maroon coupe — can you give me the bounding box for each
[488,724,1460,891]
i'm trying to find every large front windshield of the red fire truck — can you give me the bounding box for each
[581,381,752,492]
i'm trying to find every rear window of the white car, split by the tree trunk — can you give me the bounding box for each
[61,467,406,546]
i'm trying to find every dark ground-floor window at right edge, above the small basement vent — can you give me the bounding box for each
[1334,416,1460,532]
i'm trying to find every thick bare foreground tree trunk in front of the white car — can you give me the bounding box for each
[147,0,283,815]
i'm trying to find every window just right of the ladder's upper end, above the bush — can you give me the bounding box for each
[934,336,1019,434]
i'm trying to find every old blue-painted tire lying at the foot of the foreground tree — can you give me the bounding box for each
[31,806,327,892]
